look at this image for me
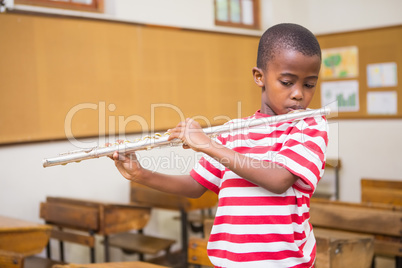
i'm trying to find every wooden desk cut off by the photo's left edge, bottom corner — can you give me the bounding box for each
[0,216,52,267]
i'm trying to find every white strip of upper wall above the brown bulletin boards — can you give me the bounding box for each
[5,0,402,35]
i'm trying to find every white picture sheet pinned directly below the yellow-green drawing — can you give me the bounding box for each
[321,80,360,112]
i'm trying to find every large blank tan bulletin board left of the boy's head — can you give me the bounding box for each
[0,13,261,144]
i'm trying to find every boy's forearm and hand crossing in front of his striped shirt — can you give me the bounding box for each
[169,119,298,194]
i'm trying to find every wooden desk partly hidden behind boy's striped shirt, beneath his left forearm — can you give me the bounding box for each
[130,182,218,267]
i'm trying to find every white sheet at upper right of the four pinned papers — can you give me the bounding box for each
[367,62,398,88]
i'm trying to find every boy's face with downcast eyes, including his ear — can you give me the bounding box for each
[253,49,321,115]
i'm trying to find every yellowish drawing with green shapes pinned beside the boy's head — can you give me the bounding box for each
[320,46,359,79]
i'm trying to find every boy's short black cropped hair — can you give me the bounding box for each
[257,23,321,70]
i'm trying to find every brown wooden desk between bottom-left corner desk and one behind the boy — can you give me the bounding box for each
[40,197,151,262]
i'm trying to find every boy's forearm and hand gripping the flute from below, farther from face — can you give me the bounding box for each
[113,152,207,198]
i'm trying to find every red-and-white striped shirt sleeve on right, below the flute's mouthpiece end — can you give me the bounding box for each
[273,116,328,194]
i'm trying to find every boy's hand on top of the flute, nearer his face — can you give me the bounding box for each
[168,118,211,152]
